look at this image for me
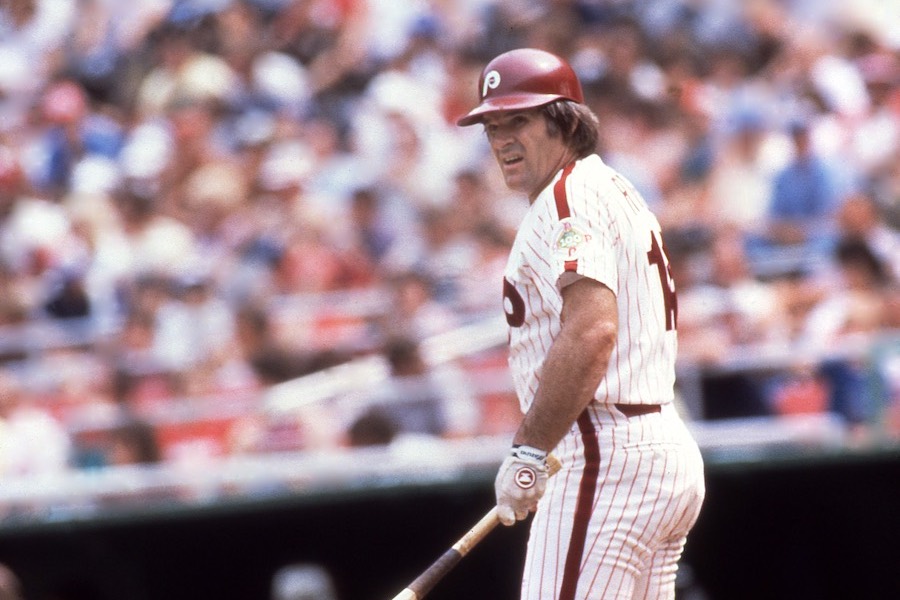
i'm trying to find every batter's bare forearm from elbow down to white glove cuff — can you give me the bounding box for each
[513,324,615,452]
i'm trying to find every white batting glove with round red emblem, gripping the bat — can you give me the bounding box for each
[494,446,547,525]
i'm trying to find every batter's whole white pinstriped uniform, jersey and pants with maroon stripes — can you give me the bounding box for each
[503,155,705,600]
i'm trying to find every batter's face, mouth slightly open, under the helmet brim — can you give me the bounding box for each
[484,109,574,201]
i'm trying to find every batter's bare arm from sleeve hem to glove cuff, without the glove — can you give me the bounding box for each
[513,277,618,452]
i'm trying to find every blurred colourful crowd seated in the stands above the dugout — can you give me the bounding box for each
[0,0,900,475]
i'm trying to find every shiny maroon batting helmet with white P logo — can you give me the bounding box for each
[456,48,584,127]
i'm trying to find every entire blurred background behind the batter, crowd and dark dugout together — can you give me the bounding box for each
[0,0,900,600]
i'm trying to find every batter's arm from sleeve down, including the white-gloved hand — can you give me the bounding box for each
[495,278,618,525]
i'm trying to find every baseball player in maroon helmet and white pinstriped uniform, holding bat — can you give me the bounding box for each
[458,49,705,600]
